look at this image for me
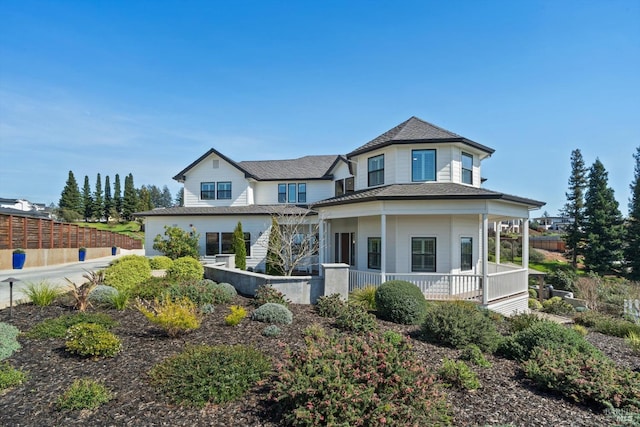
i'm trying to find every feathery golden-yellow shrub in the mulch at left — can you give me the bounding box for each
[136,295,200,338]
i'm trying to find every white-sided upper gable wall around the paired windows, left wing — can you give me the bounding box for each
[184,154,249,207]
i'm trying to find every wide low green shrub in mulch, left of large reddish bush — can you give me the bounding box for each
[150,345,271,408]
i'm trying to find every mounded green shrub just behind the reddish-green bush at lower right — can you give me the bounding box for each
[499,320,599,361]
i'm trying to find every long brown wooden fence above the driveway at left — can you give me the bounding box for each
[0,214,142,249]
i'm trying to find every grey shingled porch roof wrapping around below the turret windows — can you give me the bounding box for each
[312,182,545,208]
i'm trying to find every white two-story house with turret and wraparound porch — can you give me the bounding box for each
[138,117,544,312]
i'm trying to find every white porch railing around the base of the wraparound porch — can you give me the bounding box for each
[349,264,528,302]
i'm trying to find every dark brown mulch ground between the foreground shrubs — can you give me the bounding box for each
[0,296,640,427]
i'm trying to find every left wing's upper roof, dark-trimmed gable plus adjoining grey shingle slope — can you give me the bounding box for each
[173,148,344,182]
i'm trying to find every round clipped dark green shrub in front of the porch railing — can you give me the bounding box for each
[376,280,427,325]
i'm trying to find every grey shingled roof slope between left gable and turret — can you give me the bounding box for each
[238,155,341,181]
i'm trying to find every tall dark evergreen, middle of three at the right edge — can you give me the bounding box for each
[584,159,624,273]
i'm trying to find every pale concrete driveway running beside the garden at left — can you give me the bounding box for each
[0,249,144,309]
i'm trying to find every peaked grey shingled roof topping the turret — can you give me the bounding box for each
[347,116,495,157]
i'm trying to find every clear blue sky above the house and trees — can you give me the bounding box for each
[0,0,640,216]
